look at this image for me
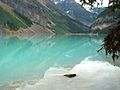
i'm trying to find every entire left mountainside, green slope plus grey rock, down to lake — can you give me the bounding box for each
[0,0,89,34]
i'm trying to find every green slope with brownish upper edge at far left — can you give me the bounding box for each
[0,2,32,33]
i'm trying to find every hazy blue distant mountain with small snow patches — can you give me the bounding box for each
[51,0,97,26]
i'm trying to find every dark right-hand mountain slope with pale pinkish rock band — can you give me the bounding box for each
[91,8,120,34]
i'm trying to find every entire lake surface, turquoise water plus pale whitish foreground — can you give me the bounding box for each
[0,36,120,90]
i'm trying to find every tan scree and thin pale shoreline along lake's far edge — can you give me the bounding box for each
[1,24,107,36]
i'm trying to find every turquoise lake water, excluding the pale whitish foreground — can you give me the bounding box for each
[0,35,119,90]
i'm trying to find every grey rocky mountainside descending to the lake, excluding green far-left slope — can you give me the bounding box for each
[1,0,89,34]
